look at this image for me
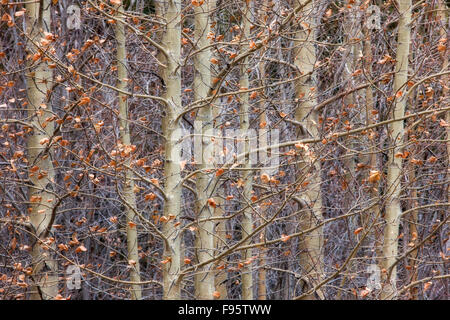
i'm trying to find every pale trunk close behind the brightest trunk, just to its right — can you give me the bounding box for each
[194,0,214,300]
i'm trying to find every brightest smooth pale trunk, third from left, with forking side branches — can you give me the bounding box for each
[162,0,182,300]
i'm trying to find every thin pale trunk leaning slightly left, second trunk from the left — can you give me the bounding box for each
[114,5,142,300]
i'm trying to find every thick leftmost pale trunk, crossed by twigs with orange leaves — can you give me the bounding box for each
[25,0,58,300]
